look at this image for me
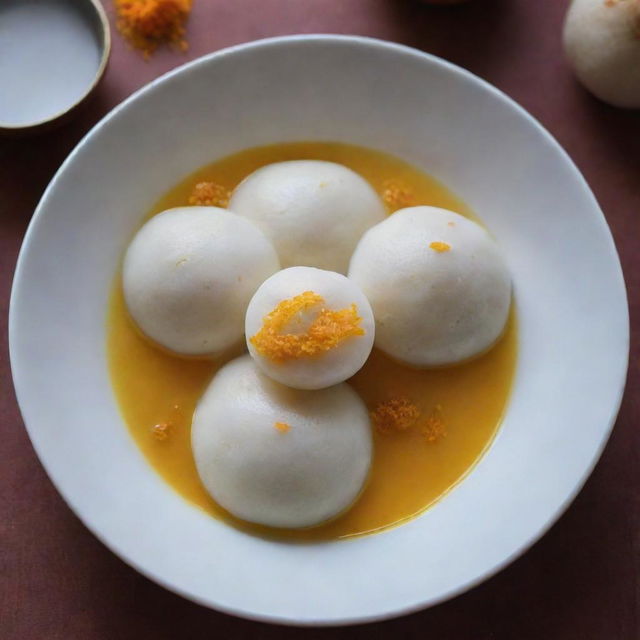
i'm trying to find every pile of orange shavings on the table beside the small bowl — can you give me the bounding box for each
[114,0,192,58]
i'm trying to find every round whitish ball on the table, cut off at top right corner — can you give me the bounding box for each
[564,0,640,109]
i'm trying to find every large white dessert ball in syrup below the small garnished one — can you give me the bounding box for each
[191,355,372,528]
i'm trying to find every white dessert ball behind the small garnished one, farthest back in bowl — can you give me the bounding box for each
[229,160,385,273]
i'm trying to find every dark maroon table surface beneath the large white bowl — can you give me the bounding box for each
[0,0,640,640]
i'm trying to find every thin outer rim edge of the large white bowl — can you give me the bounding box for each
[8,33,630,627]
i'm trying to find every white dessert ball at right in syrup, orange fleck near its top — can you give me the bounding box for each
[349,207,511,367]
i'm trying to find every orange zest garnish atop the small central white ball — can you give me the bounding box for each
[250,291,364,362]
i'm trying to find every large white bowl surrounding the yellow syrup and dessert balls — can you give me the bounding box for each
[10,36,629,624]
